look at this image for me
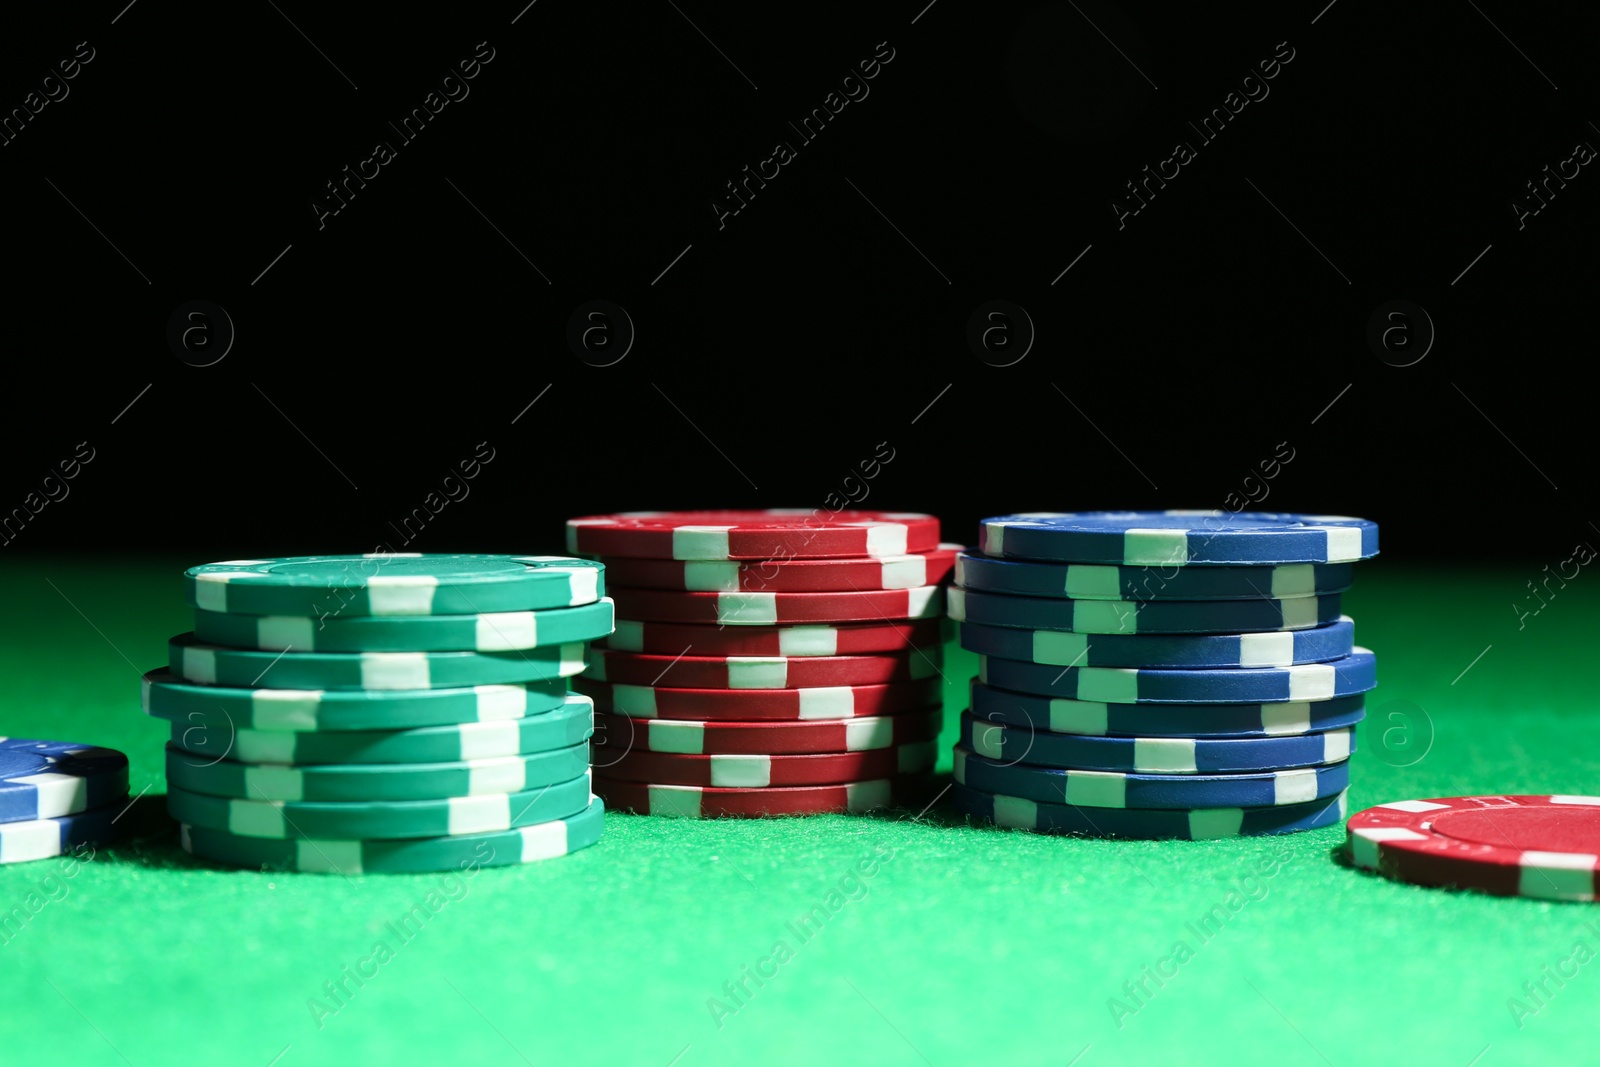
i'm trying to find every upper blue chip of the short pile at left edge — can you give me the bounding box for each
[0,737,128,822]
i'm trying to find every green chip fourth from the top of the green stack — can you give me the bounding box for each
[141,670,566,735]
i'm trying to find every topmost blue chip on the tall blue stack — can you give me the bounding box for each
[978,512,1378,566]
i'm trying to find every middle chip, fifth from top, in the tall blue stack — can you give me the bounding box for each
[978,648,1378,704]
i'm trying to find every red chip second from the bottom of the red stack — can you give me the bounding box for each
[594,741,939,789]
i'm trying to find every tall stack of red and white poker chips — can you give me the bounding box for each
[566,510,960,817]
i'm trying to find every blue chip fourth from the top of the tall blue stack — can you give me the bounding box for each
[960,616,1355,669]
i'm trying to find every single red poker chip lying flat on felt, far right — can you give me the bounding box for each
[1346,797,1600,901]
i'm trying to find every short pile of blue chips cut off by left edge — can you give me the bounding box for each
[0,737,130,864]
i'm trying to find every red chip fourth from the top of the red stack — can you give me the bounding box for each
[605,619,949,656]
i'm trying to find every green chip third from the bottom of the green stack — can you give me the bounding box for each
[166,742,589,803]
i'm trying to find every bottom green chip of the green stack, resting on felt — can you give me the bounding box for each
[182,798,605,875]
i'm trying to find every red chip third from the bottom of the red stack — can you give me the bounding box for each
[589,707,944,755]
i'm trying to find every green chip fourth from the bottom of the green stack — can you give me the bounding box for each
[173,689,594,763]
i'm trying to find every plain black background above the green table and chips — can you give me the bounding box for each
[0,0,1600,561]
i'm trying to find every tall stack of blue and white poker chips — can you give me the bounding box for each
[950,512,1378,838]
